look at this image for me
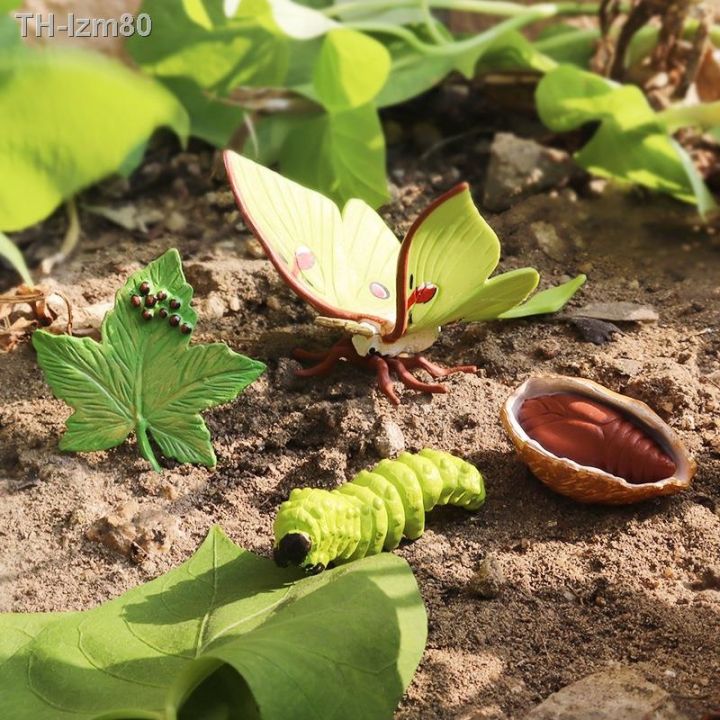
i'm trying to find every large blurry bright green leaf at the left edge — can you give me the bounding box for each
[0,46,189,230]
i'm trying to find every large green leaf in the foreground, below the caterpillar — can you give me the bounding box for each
[0,528,427,720]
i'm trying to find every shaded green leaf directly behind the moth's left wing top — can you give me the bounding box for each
[280,105,389,207]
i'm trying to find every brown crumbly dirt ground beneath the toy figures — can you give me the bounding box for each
[0,101,720,720]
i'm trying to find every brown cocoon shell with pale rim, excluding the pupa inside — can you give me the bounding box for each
[501,376,696,505]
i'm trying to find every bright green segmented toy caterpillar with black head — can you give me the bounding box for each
[274,449,485,572]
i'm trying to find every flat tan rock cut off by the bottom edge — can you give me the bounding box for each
[525,667,689,720]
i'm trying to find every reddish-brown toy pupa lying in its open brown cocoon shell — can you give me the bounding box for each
[501,376,695,504]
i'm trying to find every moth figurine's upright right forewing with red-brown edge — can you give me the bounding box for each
[385,183,500,342]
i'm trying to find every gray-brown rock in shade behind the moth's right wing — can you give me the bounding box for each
[483,133,582,211]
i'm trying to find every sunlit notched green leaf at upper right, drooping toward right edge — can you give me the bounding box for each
[535,65,715,214]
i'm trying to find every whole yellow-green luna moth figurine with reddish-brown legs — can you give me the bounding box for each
[225,150,585,404]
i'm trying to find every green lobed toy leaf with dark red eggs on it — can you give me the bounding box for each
[33,250,265,472]
